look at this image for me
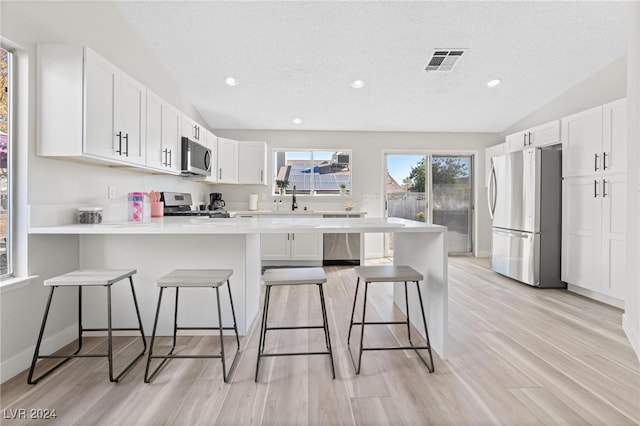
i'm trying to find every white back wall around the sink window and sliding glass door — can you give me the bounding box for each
[212,129,500,257]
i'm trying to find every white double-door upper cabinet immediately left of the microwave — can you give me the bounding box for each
[146,90,182,175]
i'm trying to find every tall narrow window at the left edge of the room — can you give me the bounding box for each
[0,47,13,278]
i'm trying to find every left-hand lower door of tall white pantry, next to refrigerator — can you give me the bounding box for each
[562,177,602,291]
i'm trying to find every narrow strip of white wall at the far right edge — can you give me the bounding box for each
[623,2,640,358]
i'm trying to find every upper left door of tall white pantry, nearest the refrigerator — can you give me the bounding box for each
[561,106,602,177]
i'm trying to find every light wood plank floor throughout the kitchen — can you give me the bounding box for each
[1,257,640,425]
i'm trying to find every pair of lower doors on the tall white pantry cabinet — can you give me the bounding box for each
[562,174,626,307]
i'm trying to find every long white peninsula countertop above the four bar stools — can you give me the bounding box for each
[29,216,447,235]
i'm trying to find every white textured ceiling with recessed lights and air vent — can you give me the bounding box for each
[116,1,627,132]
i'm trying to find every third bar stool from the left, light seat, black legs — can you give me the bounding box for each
[255,268,336,382]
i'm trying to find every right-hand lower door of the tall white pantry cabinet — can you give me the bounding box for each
[601,174,627,300]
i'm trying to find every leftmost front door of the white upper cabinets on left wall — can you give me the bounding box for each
[84,49,121,158]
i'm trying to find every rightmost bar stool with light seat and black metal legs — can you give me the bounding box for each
[347,265,434,374]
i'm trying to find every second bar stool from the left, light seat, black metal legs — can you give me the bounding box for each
[144,269,240,383]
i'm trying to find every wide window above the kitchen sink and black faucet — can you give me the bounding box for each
[273,150,351,196]
